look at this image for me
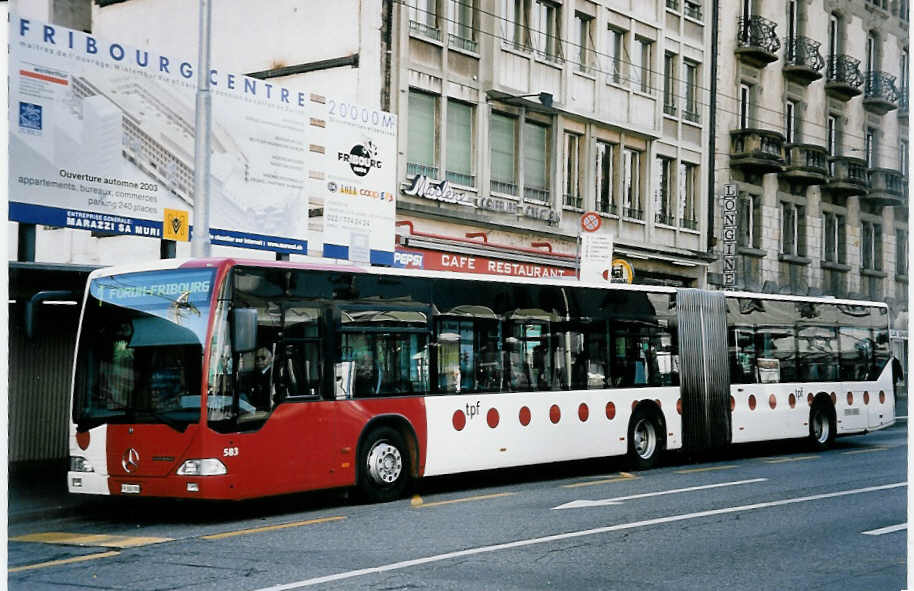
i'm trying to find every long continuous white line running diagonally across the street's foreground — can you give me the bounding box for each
[251,482,908,591]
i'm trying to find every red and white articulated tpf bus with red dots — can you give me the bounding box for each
[67,259,895,501]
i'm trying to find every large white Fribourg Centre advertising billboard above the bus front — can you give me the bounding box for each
[9,15,396,262]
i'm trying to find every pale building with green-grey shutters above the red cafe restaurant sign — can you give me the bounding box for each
[390,0,710,286]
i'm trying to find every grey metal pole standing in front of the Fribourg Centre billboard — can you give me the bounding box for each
[190,0,213,258]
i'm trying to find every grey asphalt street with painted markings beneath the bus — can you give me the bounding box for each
[8,421,907,591]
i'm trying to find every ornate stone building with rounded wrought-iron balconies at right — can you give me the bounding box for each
[711,0,909,388]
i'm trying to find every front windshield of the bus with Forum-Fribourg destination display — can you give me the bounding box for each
[73,269,214,431]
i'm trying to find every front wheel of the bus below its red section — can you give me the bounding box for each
[359,427,410,502]
